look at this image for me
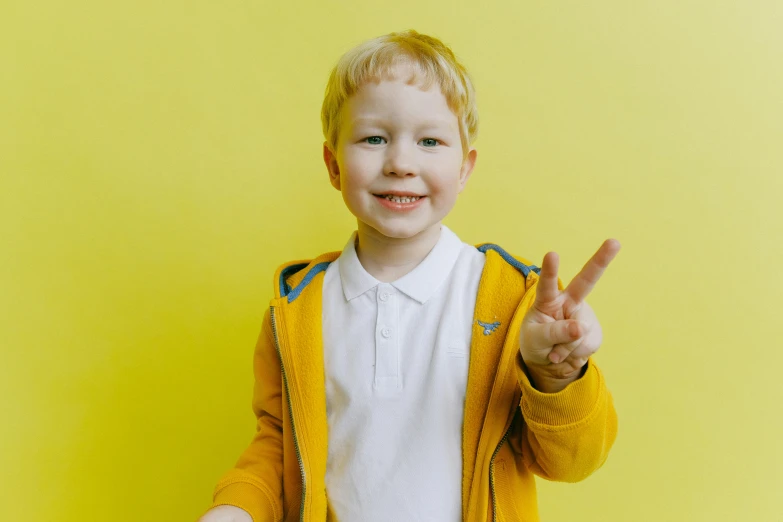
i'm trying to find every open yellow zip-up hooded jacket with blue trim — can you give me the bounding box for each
[213,243,617,522]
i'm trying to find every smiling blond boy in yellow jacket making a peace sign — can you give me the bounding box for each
[201,31,620,522]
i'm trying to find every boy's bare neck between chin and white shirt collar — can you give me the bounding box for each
[355,222,441,283]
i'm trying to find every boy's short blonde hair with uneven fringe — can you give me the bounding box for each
[321,29,478,158]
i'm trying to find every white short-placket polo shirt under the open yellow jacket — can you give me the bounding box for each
[323,225,485,522]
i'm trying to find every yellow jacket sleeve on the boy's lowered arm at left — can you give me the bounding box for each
[212,309,283,522]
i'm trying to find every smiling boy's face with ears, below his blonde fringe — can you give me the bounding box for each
[324,65,476,239]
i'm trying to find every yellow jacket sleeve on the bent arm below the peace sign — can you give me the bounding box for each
[512,354,617,482]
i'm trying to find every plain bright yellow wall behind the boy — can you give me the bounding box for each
[0,0,783,522]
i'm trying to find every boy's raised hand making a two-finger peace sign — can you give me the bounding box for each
[519,239,620,392]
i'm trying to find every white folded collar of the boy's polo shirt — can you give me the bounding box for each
[338,224,462,304]
